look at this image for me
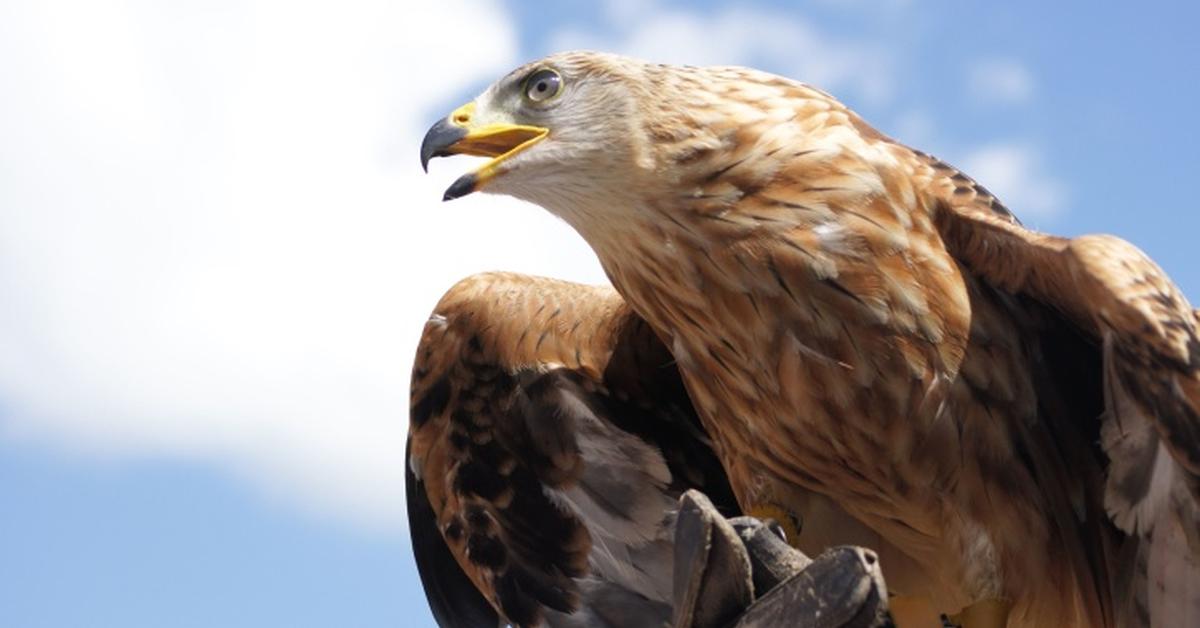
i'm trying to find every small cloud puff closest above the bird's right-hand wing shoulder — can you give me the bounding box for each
[962,144,1067,225]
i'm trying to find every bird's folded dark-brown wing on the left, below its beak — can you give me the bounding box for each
[408,274,736,627]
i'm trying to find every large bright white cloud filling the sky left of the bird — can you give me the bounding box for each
[0,0,600,531]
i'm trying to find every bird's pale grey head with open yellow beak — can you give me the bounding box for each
[421,53,653,210]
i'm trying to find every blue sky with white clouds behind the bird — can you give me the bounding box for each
[0,0,1200,627]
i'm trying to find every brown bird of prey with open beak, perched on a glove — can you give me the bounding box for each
[409,52,1200,628]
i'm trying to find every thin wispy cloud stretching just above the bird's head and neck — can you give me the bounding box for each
[550,5,894,103]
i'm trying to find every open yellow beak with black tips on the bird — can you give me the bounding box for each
[421,102,550,201]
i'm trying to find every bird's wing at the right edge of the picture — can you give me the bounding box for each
[937,166,1200,626]
